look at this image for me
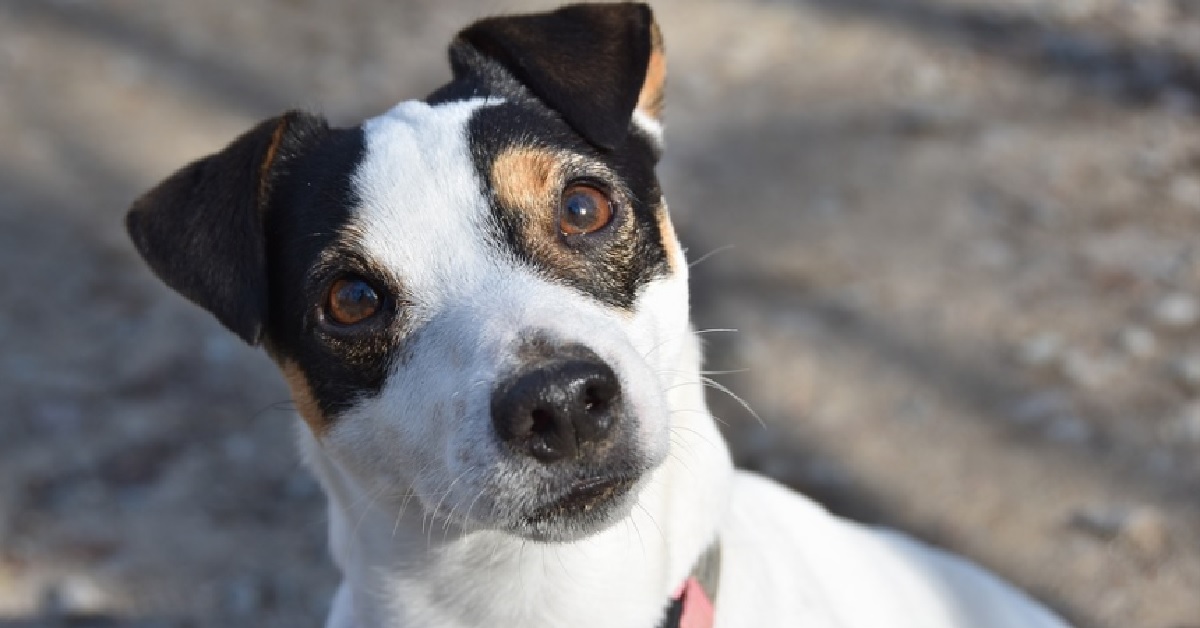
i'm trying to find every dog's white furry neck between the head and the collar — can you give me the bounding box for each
[301,337,731,628]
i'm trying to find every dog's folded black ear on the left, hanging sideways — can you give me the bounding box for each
[125,112,329,345]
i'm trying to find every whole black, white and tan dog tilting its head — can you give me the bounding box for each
[126,4,1066,628]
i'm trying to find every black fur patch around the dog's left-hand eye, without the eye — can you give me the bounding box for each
[258,127,403,420]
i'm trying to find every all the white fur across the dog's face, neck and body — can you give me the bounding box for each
[301,100,1058,628]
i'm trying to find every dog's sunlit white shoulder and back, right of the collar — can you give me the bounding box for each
[718,472,1064,628]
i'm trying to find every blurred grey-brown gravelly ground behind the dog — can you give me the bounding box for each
[0,0,1200,628]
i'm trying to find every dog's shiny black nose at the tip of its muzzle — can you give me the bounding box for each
[492,347,620,462]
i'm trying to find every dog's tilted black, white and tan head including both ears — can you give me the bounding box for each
[127,4,689,540]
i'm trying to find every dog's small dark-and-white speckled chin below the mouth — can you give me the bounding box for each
[510,476,641,543]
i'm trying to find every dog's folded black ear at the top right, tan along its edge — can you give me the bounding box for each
[450,4,666,150]
